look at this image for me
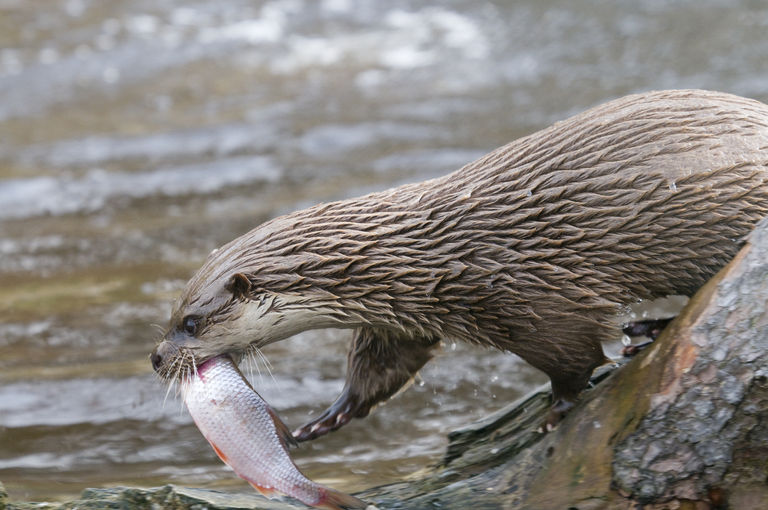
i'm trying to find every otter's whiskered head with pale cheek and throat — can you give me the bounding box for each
[150,245,344,379]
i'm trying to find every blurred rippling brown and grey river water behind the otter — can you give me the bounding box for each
[0,0,768,500]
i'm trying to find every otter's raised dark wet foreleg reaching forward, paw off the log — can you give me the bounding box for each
[293,328,438,441]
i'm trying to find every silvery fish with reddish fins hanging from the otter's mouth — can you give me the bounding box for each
[181,355,367,510]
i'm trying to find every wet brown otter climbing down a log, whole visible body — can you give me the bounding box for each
[151,90,768,440]
